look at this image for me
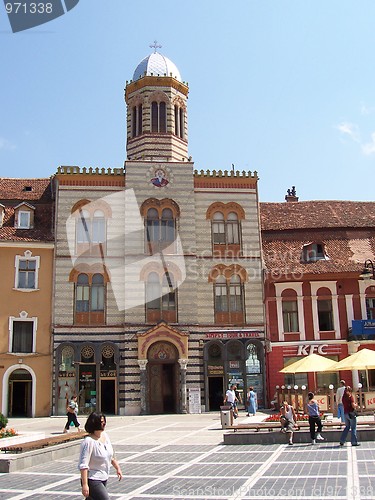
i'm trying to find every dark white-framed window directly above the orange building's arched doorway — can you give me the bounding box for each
[9,311,37,354]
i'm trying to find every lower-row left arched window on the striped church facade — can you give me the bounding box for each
[75,273,105,325]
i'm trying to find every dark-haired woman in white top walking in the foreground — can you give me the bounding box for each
[78,412,122,500]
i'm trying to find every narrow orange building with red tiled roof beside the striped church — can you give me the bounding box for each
[0,178,54,417]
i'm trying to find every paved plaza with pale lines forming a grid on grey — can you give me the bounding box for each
[0,413,375,500]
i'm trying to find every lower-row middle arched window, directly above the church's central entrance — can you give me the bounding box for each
[146,271,177,323]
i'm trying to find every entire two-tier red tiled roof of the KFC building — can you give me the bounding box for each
[260,201,375,280]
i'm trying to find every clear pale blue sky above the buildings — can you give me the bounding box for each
[0,0,375,201]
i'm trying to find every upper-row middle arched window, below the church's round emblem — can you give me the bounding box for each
[141,200,178,254]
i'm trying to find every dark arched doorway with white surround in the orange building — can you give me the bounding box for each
[8,369,32,417]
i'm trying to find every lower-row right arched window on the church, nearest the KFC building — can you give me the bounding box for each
[214,274,245,324]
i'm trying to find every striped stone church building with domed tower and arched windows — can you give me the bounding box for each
[53,44,266,415]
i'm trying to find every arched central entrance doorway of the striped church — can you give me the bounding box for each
[147,341,180,415]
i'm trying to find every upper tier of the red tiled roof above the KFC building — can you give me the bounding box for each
[260,201,375,231]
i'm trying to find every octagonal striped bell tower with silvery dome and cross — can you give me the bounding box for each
[125,42,189,162]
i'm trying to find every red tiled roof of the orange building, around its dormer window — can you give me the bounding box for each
[0,178,54,242]
